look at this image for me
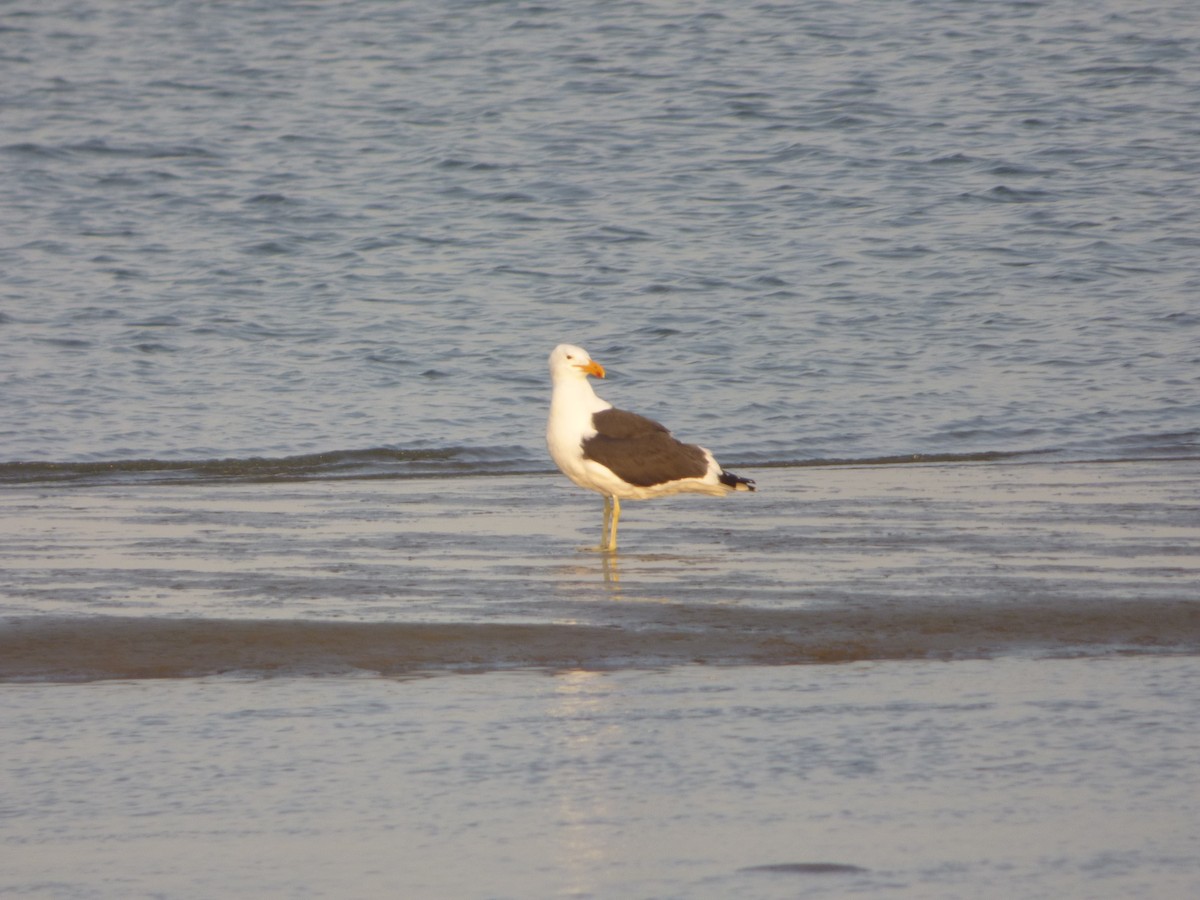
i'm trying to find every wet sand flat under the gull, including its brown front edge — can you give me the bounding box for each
[0,461,1200,679]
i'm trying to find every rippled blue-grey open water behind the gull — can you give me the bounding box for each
[0,0,1200,479]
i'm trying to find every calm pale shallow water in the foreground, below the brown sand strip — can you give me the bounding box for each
[0,656,1200,900]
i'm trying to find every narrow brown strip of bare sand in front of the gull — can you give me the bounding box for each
[0,600,1200,682]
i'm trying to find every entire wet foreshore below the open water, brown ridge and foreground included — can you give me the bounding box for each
[0,461,1200,899]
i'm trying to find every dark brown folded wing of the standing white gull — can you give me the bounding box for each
[583,409,708,487]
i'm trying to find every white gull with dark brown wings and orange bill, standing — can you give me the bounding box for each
[546,343,755,551]
